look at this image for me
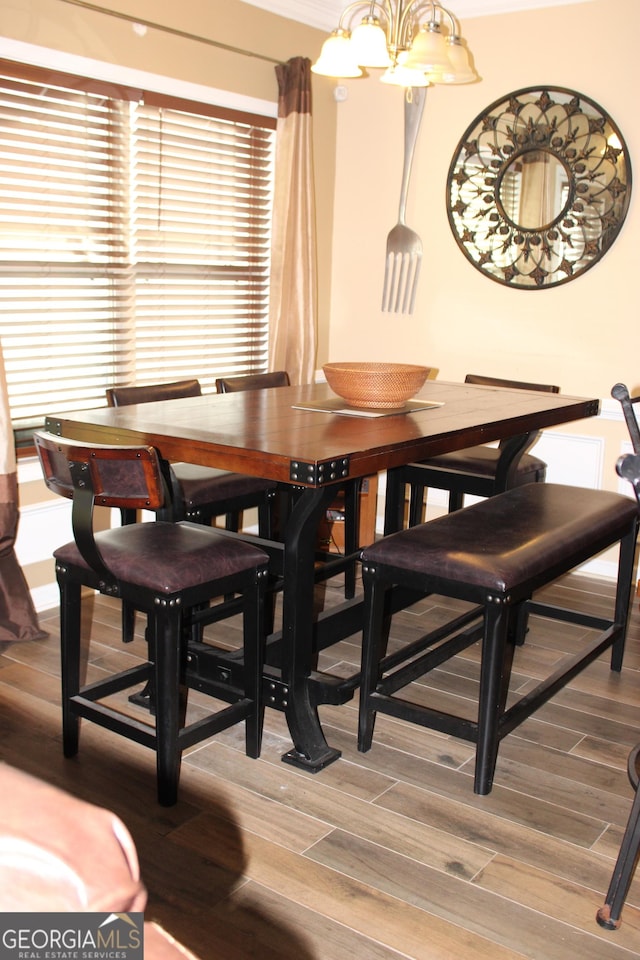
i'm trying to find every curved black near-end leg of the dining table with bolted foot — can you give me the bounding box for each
[281,484,340,773]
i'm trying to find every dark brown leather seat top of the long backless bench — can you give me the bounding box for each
[362,483,637,593]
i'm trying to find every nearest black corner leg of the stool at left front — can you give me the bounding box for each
[151,604,186,807]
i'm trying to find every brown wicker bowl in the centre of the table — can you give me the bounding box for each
[322,361,431,409]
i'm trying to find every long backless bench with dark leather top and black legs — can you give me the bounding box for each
[358,483,638,794]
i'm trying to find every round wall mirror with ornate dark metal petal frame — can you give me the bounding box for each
[447,87,631,290]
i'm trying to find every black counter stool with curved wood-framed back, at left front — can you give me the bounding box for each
[34,431,267,806]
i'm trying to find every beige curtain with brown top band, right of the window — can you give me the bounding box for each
[269,57,317,383]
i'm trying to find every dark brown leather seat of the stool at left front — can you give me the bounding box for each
[54,521,268,595]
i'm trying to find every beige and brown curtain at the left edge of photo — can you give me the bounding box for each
[0,347,48,643]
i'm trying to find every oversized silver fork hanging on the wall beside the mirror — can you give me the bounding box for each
[382,87,427,313]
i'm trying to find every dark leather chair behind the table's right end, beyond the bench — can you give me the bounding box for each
[385,373,560,533]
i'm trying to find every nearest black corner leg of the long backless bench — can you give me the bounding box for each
[473,602,513,795]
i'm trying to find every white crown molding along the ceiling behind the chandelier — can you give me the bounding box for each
[244,0,593,30]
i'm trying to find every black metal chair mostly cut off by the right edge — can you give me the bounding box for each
[596,454,640,930]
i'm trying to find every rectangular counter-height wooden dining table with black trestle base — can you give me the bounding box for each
[45,380,600,773]
